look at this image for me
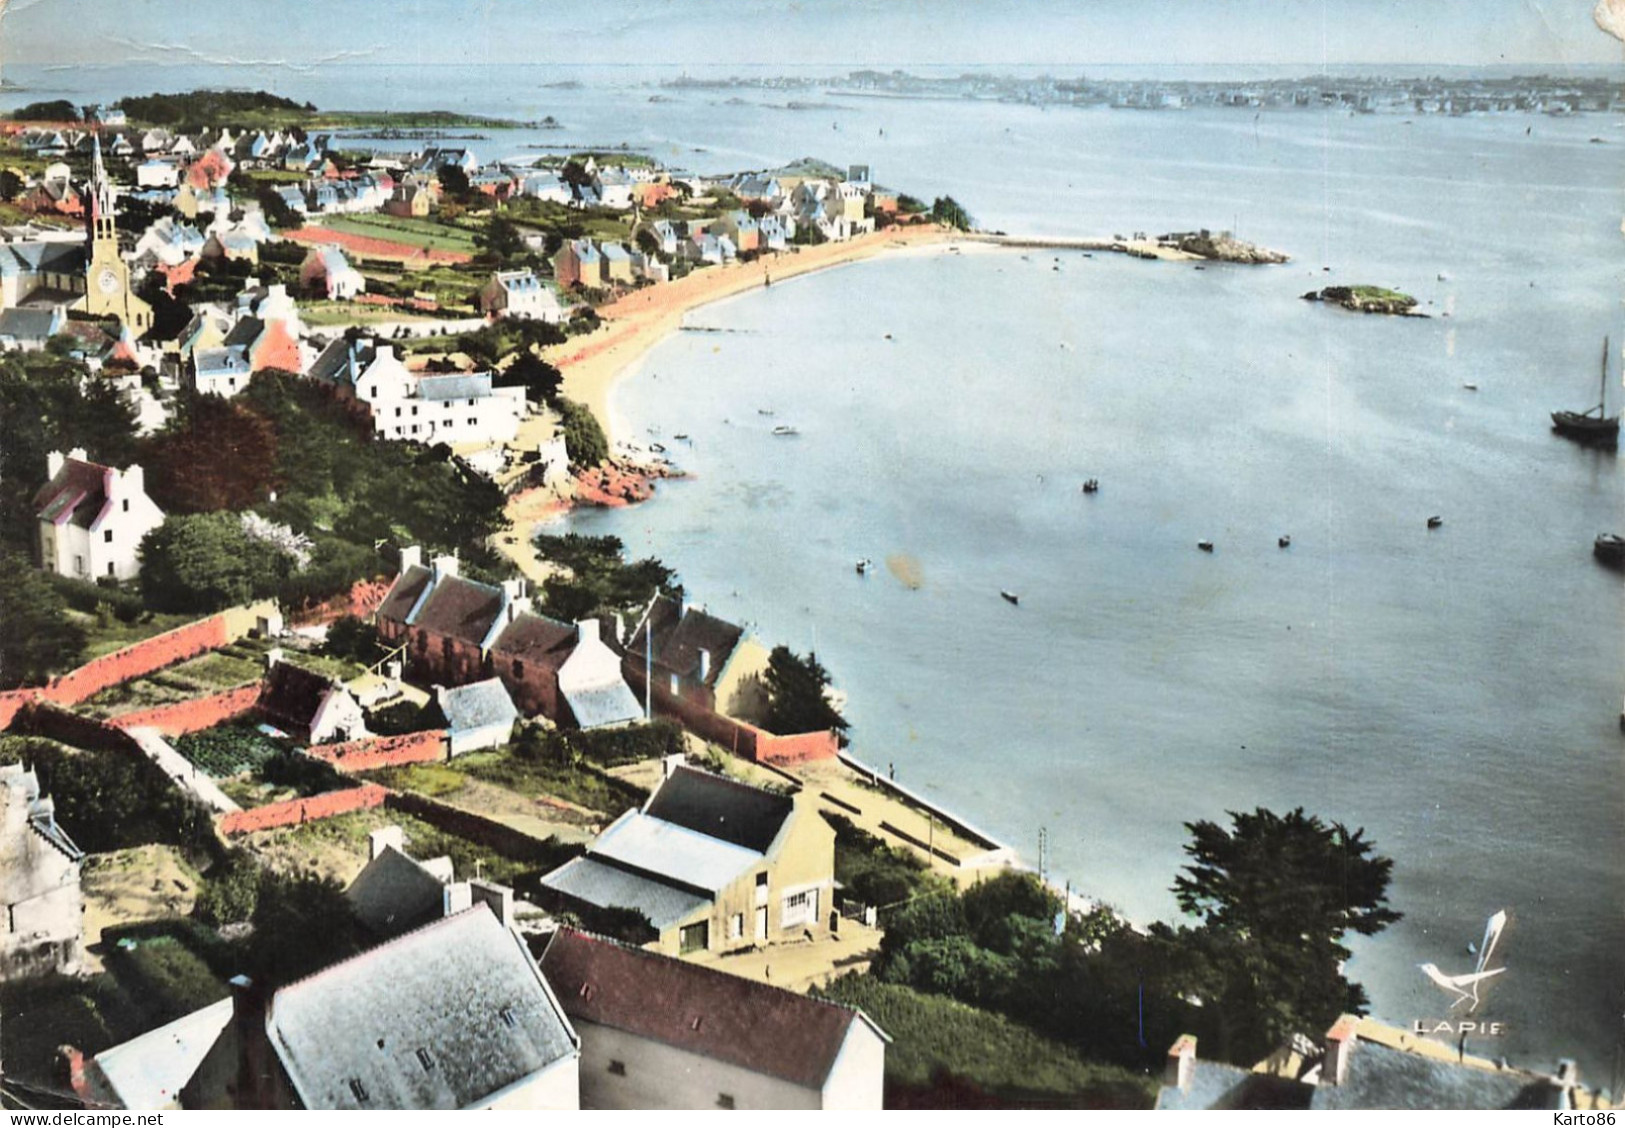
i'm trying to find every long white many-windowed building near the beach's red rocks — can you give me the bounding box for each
[310,338,525,445]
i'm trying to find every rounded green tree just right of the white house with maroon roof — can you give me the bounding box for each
[140,514,293,613]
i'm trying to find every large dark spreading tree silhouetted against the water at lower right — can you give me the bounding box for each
[1173,808,1401,1061]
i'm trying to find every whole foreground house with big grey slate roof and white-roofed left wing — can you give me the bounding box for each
[75,903,580,1110]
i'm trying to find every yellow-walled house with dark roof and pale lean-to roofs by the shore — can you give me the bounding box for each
[541,757,835,956]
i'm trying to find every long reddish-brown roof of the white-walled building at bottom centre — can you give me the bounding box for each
[541,928,886,1089]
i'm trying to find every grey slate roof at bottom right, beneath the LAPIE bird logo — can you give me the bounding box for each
[1308,1039,1558,1108]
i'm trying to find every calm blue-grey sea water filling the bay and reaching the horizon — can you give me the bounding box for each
[0,65,1625,1084]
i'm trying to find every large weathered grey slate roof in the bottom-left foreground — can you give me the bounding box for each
[267,904,579,1108]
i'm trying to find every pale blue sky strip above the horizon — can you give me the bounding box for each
[0,0,1625,68]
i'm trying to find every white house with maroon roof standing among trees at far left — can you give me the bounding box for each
[34,450,164,580]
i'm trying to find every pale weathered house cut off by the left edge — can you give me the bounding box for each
[0,764,85,982]
